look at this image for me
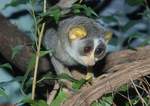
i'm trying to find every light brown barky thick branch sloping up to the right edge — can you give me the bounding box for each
[63,46,150,106]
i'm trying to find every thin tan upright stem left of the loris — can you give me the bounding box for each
[32,0,46,100]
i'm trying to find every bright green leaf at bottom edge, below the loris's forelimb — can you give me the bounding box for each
[50,89,68,106]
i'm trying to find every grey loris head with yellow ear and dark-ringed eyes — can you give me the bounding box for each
[59,16,111,66]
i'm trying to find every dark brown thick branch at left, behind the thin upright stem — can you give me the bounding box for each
[0,14,49,71]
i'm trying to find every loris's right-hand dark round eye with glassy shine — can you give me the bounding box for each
[94,44,106,58]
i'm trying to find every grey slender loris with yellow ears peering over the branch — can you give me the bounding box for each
[44,16,110,79]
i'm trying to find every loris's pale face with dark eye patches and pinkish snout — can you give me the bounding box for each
[71,38,106,66]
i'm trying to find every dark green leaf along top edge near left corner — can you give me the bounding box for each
[4,0,29,8]
